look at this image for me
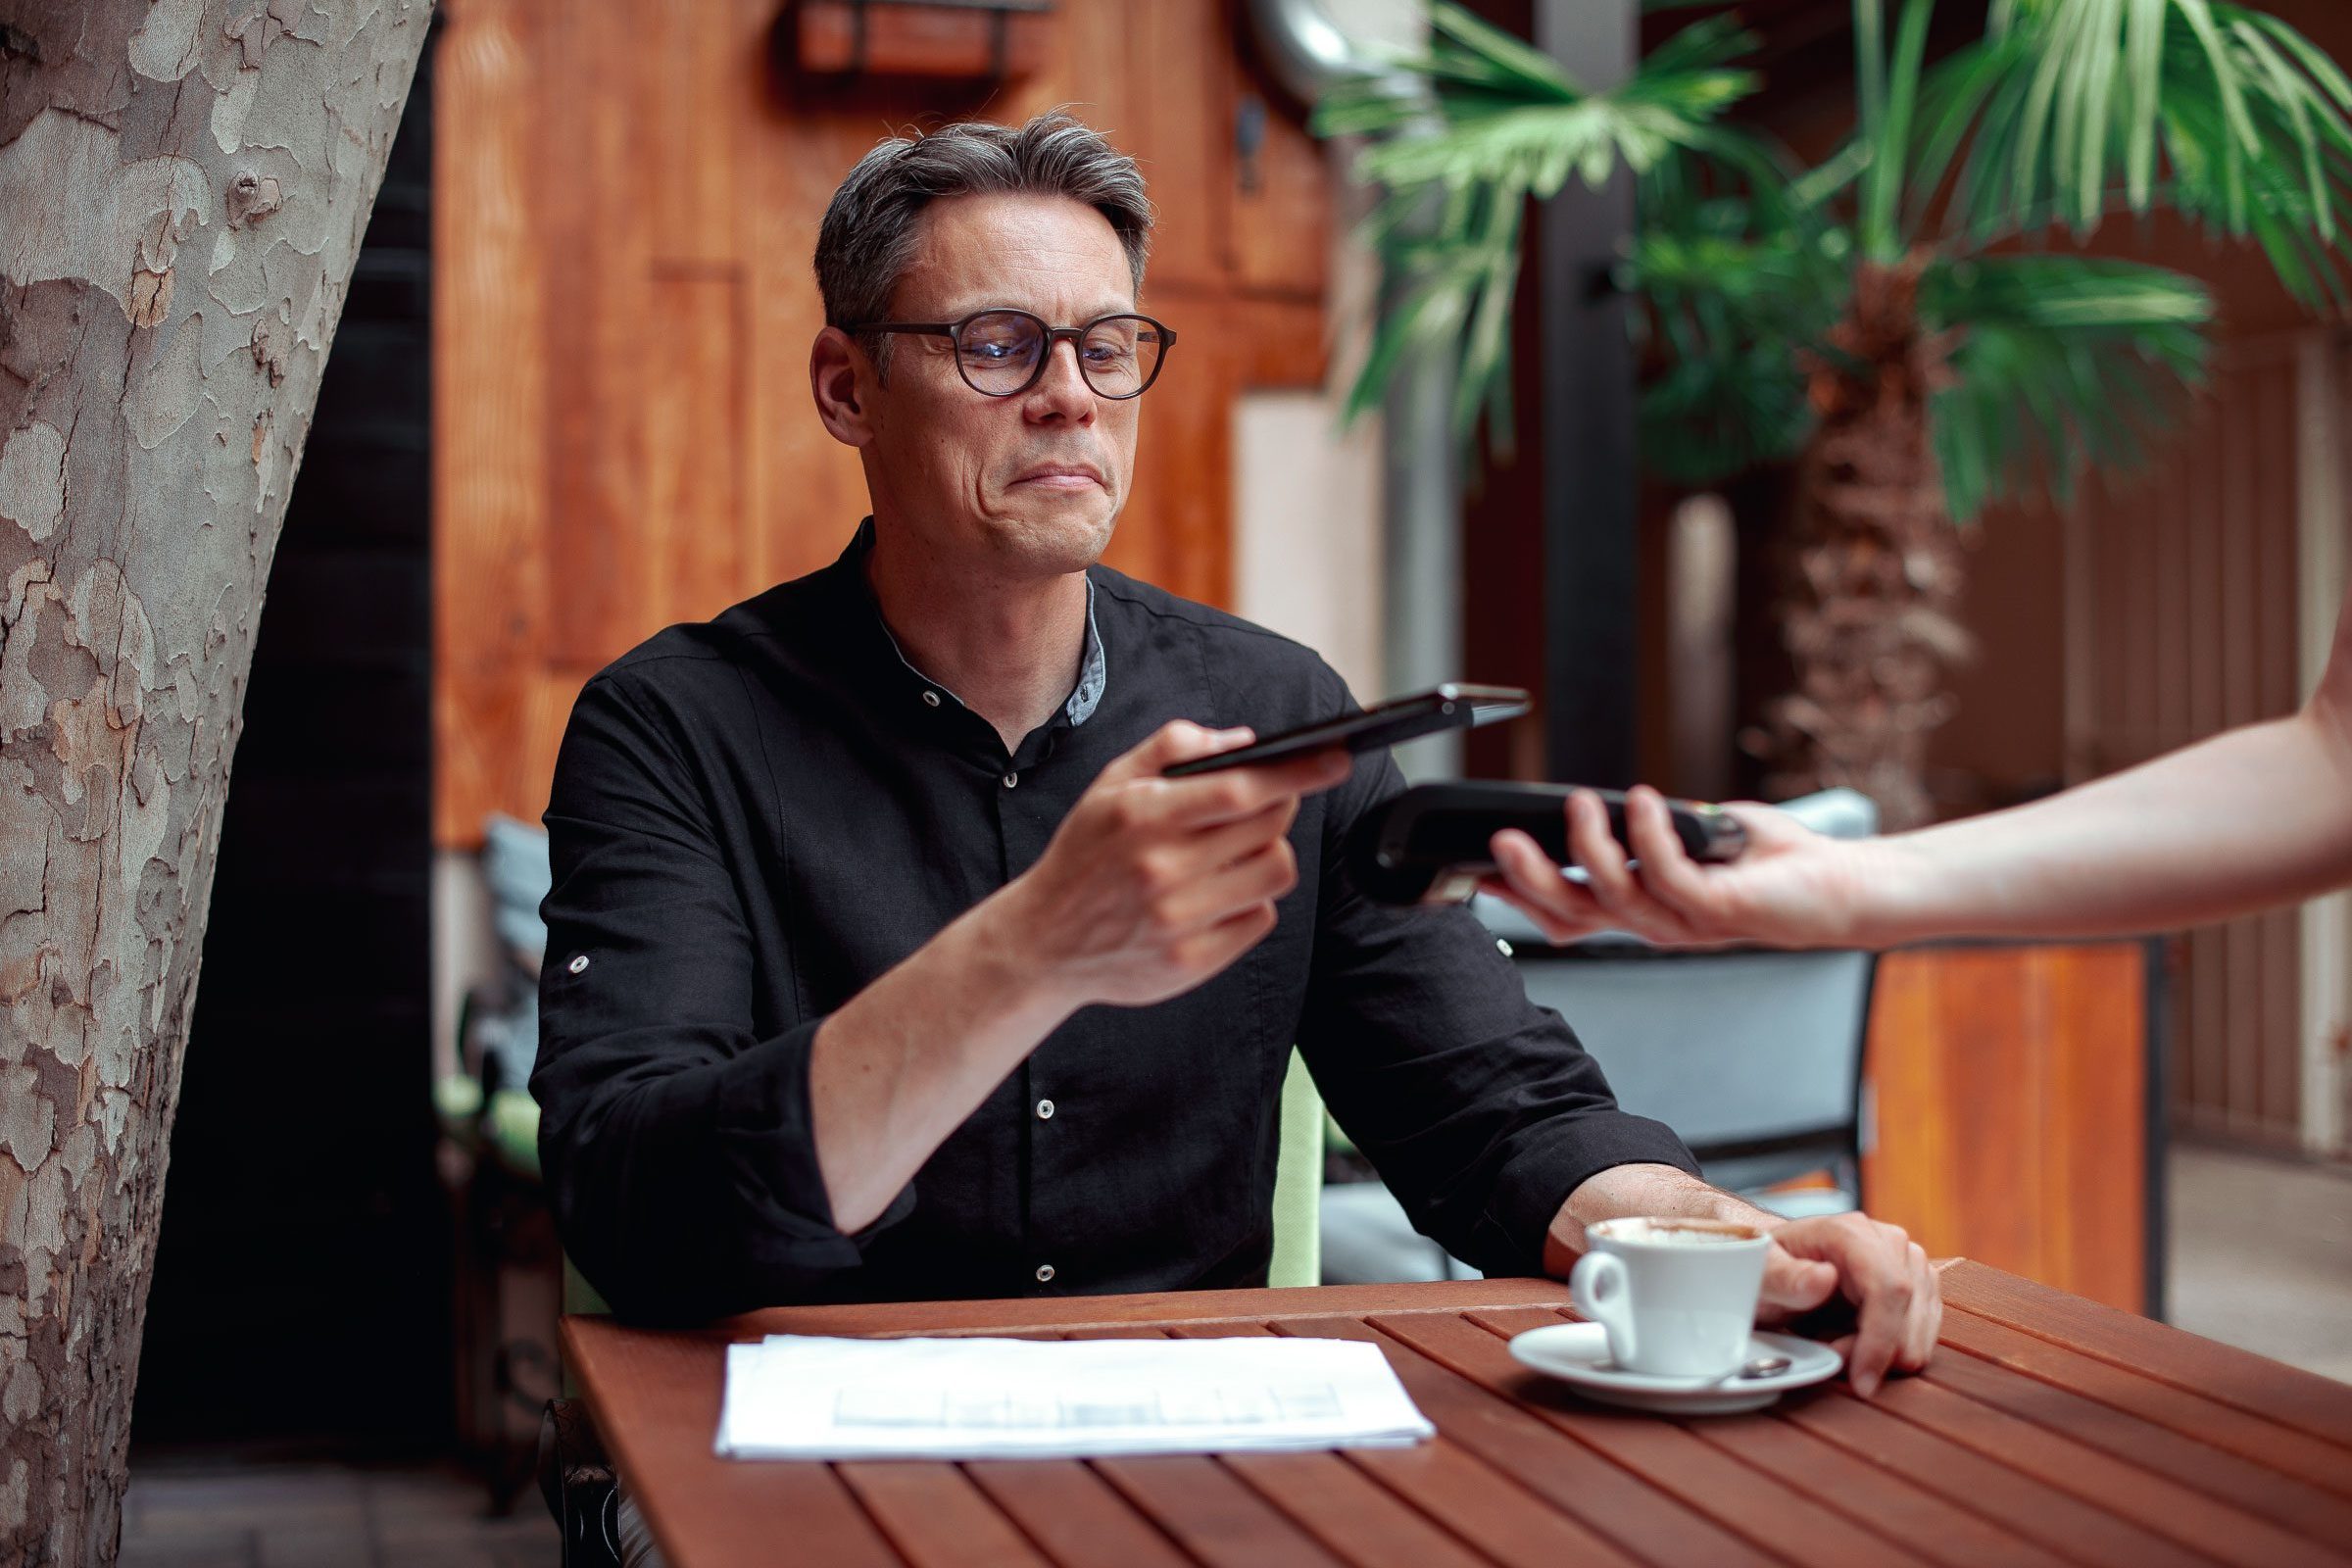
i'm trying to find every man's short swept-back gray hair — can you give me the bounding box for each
[816,111,1152,367]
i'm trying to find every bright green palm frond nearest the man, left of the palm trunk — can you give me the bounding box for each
[1315,0,1783,447]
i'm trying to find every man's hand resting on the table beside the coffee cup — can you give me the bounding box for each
[1757,1213,1942,1398]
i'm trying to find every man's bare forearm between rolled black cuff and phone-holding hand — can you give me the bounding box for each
[809,894,1077,1230]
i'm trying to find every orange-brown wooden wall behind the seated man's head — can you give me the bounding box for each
[433,0,1331,847]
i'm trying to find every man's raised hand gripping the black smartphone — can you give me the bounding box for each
[1002,719,1352,1006]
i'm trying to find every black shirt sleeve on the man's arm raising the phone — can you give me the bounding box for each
[531,674,915,1321]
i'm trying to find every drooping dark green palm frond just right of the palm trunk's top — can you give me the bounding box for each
[1919,256,2213,522]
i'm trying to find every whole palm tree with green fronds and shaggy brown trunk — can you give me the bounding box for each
[1317,0,2352,823]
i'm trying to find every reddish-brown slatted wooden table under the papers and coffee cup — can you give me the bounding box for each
[564,1262,2352,1568]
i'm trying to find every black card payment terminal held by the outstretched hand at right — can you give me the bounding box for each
[1348,780,1747,903]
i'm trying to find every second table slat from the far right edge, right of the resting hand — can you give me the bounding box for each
[1942,1312,2352,1497]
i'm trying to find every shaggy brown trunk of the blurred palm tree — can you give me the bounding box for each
[1766,261,1969,827]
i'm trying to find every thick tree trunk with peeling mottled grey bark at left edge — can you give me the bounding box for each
[0,0,430,1566]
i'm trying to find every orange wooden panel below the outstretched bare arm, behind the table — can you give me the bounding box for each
[1863,943,2147,1312]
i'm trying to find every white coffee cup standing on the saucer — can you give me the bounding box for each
[1569,1218,1771,1378]
